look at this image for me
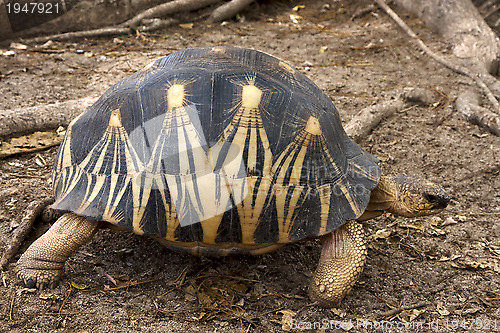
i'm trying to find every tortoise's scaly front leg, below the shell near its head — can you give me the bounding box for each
[309,221,367,307]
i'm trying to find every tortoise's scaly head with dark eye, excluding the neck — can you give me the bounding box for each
[377,176,450,217]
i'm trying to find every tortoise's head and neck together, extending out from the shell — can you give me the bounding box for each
[358,176,450,221]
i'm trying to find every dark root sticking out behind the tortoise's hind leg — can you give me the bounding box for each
[0,198,54,270]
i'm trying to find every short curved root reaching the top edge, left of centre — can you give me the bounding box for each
[119,0,220,28]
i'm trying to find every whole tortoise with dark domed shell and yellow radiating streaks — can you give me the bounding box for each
[16,46,449,306]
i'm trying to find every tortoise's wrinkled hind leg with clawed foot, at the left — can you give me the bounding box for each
[16,213,99,289]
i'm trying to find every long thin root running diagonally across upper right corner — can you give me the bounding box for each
[375,0,500,114]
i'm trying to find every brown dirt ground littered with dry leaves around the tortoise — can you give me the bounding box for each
[0,0,500,332]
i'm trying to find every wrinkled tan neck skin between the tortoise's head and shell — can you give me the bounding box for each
[357,176,399,222]
